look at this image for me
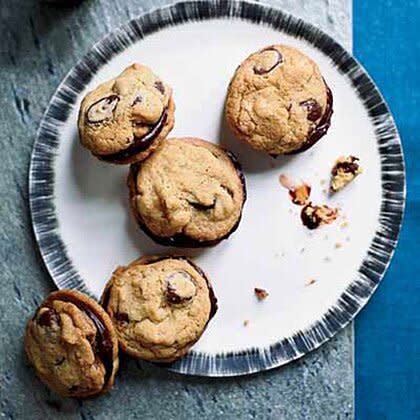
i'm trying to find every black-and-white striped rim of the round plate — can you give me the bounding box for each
[29,0,405,376]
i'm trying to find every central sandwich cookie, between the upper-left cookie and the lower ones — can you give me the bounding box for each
[128,138,246,246]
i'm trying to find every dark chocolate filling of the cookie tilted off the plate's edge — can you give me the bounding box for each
[37,296,114,386]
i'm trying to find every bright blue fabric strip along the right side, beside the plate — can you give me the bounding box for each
[353,0,420,420]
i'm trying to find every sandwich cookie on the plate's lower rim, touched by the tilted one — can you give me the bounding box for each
[102,257,217,362]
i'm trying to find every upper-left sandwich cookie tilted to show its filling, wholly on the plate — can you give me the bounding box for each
[78,64,175,164]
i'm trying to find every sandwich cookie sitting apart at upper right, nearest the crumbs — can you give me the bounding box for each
[225,45,332,156]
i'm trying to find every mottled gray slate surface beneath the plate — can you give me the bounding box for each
[0,0,353,420]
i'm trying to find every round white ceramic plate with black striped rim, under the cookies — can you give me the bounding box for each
[30,1,405,376]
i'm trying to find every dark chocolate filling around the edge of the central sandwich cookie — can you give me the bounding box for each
[130,150,247,248]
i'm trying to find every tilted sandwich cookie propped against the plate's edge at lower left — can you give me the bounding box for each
[25,289,118,398]
